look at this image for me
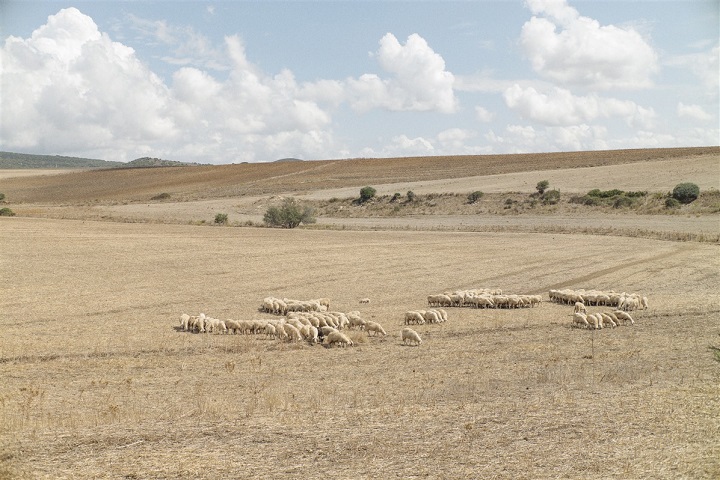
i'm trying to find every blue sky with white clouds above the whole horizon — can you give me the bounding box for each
[0,0,720,164]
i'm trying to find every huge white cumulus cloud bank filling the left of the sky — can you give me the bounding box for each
[0,8,337,162]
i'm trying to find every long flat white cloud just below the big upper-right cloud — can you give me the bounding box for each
[503,84,655,127]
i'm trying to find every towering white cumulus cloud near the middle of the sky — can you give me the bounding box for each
[347,33,458,113]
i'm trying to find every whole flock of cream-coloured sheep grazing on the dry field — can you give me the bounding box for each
[174,288,648,347]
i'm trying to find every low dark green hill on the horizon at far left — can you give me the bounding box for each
[0,152,200,169]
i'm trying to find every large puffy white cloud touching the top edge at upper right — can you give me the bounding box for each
[520,0,658,89]
